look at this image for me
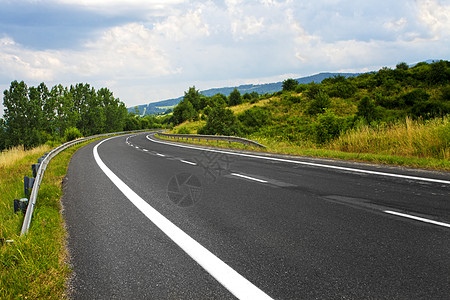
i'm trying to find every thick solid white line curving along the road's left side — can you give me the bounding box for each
[93,137,272,300]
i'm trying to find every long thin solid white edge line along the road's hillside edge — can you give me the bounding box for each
[146,135,450,184]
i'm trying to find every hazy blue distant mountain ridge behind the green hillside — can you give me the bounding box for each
[128,73,360,116]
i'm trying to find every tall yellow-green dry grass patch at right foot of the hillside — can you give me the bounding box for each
[328,118,450,160]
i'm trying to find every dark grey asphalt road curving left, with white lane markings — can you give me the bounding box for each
[63,134,450,299]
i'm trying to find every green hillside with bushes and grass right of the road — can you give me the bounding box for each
[161,61,450,170]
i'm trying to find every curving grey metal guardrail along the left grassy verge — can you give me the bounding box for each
[20,129,158,235]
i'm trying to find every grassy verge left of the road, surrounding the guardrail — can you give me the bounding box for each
[0,144,91,299]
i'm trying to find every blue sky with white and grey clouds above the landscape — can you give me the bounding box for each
[0,0,450,110]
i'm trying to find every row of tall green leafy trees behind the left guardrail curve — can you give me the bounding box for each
[0,81,161,150]
